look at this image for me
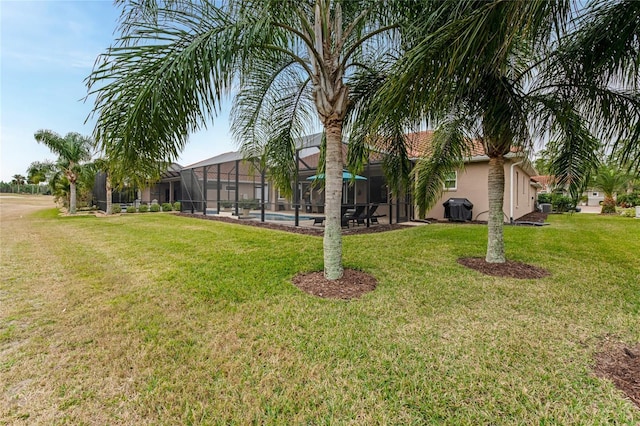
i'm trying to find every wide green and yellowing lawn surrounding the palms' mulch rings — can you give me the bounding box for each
[0,205,640,425]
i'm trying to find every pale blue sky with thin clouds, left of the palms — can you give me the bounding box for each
[0,0,236,182]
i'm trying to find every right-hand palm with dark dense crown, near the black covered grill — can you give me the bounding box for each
[358,0,640,263]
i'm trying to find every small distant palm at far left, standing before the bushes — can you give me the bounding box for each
[34,130,93,214]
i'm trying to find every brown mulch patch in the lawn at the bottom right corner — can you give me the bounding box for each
[594,339,640,408]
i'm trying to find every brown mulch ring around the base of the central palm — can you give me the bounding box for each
[293,269,378,300]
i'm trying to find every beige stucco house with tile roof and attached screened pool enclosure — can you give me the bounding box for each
[175,131,541,223]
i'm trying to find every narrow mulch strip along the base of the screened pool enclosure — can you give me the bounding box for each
[177,213,406,237]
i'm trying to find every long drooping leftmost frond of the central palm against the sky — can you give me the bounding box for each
[87,2,234,173]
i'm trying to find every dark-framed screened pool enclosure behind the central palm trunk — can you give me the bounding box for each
[180,133,413,226]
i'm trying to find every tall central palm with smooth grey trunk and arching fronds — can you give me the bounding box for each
[88,0,402,280]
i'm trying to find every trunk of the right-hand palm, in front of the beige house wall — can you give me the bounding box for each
[485,156,505,263]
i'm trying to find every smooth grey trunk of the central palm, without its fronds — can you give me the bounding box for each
[323,121,343,280]
